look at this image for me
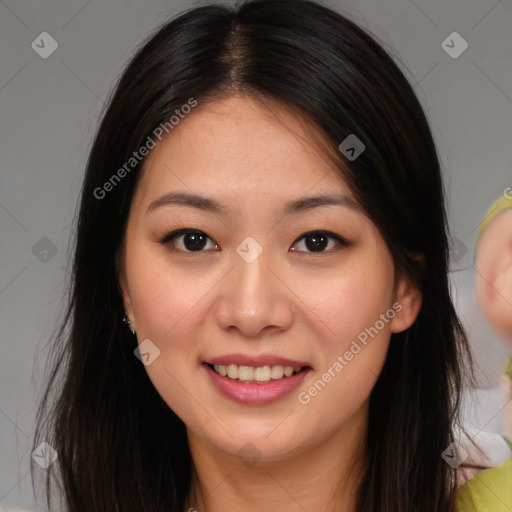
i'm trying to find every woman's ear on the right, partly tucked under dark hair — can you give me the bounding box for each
[390,273,423,333]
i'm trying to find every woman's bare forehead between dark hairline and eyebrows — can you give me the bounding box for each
[132,96,351,210]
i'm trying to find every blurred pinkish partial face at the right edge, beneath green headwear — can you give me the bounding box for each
[475,209,512,340]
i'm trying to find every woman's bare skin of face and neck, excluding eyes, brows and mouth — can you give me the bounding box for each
[119,96,421,512]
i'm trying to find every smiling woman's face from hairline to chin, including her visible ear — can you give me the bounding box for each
[120,93,421,460]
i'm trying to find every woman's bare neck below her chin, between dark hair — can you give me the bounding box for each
[185,405,368,512]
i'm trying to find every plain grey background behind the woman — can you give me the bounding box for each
[0,0,512,510]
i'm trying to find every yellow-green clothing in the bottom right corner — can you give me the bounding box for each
[457,459,512,512]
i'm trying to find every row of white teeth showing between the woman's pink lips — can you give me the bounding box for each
[205,363,311,384]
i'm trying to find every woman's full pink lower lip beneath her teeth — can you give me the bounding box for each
[203,364,310,405]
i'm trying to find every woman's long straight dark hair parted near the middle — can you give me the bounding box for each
[31,0,472,512]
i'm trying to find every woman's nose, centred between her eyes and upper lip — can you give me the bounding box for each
[215,241,294,338]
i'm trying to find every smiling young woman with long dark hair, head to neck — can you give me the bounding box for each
[34,0,488,512]
